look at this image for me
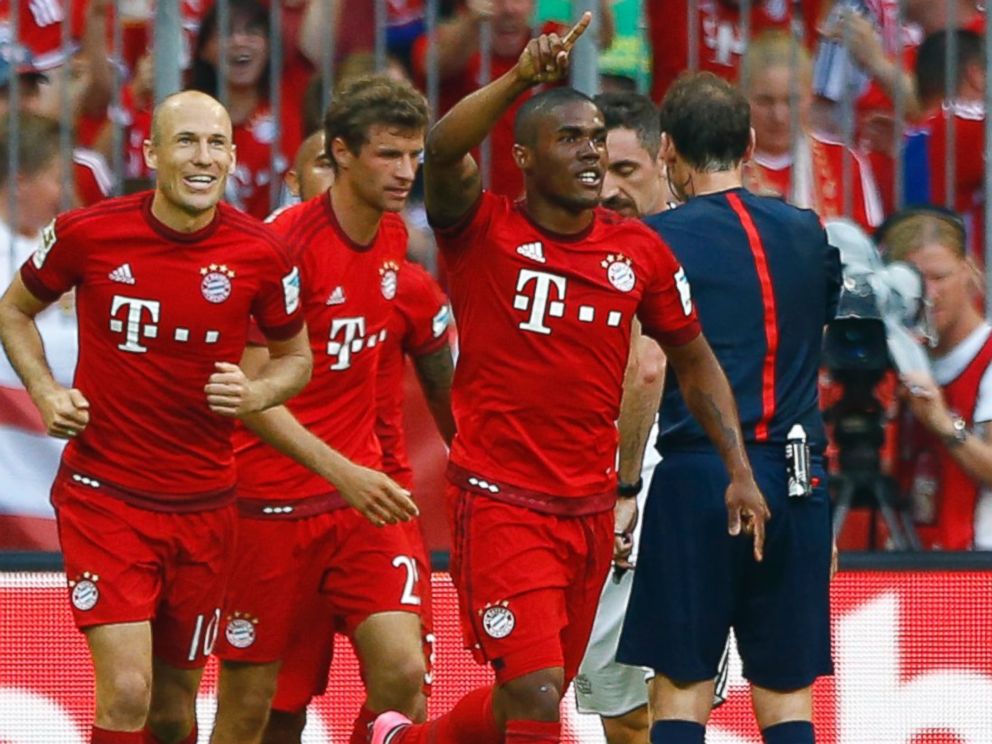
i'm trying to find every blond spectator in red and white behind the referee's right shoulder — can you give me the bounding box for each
[743,31,883,230]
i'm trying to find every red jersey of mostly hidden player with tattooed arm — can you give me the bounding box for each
[375,261,451,488]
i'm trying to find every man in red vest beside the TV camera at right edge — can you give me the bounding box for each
[878,207,992,550]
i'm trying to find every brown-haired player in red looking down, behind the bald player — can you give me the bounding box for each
[214,76,427,743]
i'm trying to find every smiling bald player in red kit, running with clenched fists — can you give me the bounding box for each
[0,92,310,744]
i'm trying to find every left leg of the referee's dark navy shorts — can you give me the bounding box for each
[617,452,736,682]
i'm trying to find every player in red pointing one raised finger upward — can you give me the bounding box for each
[372,13,767,744]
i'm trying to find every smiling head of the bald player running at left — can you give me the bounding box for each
[144,91,234,232]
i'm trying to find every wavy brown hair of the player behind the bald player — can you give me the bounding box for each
[324,75,428,169]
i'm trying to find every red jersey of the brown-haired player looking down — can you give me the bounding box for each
[234,193,407,500]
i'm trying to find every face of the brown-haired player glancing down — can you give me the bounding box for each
[331,124,424,212]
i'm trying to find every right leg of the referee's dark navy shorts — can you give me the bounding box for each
[734,448,833,690]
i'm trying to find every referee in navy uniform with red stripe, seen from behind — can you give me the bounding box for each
[617,73,841,744]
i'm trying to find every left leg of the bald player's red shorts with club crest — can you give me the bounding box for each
[52,480,167,629]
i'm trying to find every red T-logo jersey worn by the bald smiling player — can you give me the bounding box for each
[21,192,303,510]
